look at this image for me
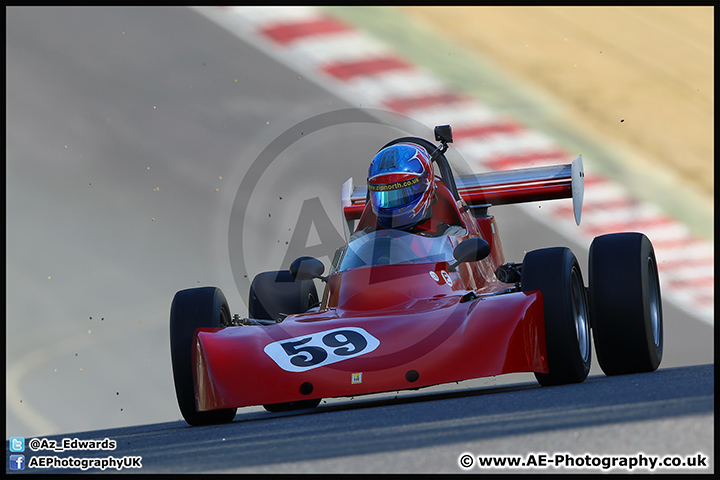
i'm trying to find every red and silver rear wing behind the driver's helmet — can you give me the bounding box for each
[342,155,585,225]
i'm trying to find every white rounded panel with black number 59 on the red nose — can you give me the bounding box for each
[265,327,380,372]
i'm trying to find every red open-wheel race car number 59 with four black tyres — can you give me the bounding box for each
[170,125,663,425]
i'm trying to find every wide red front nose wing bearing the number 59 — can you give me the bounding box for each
[193,292,548,411]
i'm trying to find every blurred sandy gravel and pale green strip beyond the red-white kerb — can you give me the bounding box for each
[331,6,715,238]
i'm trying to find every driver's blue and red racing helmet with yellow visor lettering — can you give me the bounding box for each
[367,143,435,230]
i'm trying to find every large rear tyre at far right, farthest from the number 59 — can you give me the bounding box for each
[588,233,663,375]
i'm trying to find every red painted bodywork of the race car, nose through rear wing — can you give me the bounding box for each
[193,156,582,411]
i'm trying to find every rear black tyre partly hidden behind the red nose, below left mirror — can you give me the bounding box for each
[248,270,318,320]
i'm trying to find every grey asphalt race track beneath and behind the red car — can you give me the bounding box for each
[6,8,714,473]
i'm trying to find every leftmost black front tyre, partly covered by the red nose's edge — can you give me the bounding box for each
[170,287,237,425]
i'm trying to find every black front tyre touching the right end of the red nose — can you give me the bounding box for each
[521,247,592,386]
